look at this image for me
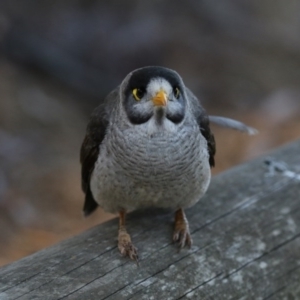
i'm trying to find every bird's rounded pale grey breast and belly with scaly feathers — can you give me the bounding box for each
[91,108,210,212]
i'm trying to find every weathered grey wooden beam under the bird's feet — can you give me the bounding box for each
[0,141,300,300]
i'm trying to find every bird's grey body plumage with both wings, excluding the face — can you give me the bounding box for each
[81,68,215,215]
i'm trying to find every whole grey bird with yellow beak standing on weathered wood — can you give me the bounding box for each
[80,66,255,260]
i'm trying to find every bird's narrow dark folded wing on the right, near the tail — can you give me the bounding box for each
[186,88,216,167]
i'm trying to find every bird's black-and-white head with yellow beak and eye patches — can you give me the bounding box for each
[121,67,186,124]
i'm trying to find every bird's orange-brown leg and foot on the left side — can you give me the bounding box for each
[118,210,138,261]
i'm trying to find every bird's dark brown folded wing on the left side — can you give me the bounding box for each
[80,88,119,216]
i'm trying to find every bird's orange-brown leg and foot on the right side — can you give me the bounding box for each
[173,208,193,248]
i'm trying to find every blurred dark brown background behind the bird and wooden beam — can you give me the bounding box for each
[0,0,300,265]
